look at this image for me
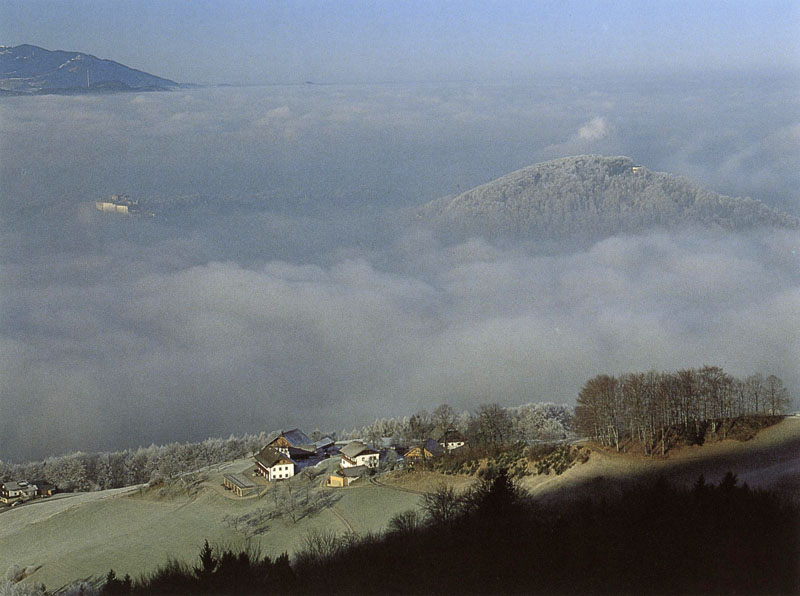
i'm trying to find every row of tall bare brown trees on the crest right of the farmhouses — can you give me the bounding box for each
[575,366,792,454]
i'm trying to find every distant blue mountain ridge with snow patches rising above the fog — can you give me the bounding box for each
[0,44,178,95]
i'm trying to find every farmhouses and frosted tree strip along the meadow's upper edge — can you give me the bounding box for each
[0,403,572,512]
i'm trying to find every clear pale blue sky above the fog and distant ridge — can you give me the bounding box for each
[0,0,800,84]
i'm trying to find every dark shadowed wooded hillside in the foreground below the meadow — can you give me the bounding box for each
[104,472,800,594]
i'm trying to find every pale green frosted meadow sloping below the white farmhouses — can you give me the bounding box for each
[0,461,419,589]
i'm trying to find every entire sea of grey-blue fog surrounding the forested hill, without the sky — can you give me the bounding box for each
[0,80,800,460]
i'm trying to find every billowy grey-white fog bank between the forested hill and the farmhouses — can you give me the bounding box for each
[0,220,800,458]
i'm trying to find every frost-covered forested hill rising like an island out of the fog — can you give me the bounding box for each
[417,155,798,243]
